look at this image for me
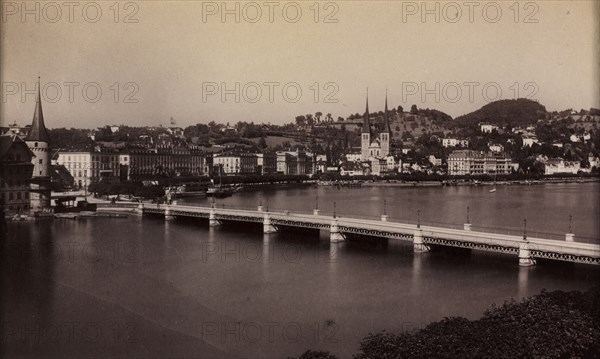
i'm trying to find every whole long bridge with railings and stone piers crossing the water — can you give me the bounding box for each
[137,204,600,266]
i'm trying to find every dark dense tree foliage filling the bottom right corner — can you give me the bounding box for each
[354,288,600,359]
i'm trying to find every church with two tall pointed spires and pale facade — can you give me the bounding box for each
[360,91,392,161]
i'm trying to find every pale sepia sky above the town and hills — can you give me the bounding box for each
[0,0,600,128]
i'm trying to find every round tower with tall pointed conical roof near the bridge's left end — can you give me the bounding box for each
[25,77,51,213]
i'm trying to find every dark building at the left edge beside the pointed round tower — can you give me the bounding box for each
[0,134,35,213]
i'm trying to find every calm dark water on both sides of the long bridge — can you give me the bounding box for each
[0,184,600,358]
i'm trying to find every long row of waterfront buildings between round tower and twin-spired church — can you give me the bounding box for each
[53,146,326,188]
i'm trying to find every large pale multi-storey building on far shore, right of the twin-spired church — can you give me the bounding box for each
[448,150,512,176]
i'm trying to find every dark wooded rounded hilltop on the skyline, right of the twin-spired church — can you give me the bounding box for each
[455,98,548,127]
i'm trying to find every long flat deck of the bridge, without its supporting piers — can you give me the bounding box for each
[143,205,600,264]
